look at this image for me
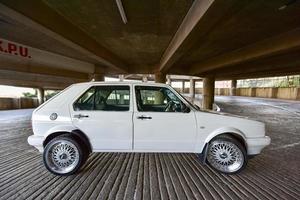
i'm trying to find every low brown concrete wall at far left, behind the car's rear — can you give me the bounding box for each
[0,97,38,110]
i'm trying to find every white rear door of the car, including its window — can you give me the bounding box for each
[70,85,133,151]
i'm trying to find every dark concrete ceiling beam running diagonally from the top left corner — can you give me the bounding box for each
[0,0,128,72]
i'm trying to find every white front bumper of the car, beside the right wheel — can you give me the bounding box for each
[246,136,271,156]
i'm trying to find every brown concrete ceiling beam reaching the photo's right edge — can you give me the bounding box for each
[189,29,300,75]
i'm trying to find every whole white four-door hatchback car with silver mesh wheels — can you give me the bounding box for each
[28,82,270,175]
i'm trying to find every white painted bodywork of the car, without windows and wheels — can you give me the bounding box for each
[28,82,270,155]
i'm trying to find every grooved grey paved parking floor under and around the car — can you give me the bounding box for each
[0,97,300,200]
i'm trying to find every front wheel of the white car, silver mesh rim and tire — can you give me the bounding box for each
[207,135,248,174]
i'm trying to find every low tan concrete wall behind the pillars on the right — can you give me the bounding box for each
[175,87,300,100]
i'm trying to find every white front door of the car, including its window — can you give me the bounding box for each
[133,85,197,152]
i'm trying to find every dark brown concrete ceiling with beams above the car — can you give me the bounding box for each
[0,0,300,88]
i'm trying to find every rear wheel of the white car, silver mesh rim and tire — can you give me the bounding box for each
[43,134,87,176]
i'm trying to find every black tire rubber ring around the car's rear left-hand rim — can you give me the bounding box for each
[43,136,85,176]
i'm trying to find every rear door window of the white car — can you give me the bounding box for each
[73,86,130,111]
